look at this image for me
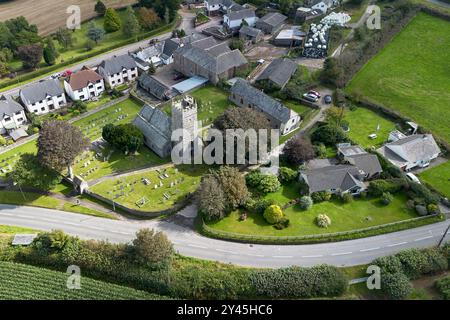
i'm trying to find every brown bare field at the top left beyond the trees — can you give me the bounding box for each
[0,0,137,35]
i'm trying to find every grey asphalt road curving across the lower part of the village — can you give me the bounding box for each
[0,205,450,268]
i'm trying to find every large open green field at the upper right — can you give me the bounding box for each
[347,13,450,141]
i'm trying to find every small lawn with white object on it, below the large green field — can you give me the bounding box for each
[344,107,395,148]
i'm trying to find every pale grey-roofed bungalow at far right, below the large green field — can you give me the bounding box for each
[377,134,441,171]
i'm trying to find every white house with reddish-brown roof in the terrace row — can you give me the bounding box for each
[64,68,105,101]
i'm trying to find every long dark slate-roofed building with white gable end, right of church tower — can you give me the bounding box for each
[229,79,300,135]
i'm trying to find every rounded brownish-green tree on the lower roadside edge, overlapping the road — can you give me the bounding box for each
[132,229,173,268]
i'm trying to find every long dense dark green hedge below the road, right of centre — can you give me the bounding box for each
[250,265,348,299]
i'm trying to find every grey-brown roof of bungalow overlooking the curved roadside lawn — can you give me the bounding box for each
[301,165,364,193]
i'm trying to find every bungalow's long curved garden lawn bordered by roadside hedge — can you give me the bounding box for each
[209,195,417,236]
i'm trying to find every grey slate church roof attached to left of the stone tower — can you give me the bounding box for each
[133,105,172,158]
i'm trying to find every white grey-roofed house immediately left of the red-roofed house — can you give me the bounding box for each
[19,79,67,114]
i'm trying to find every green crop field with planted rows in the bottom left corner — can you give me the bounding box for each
[0,262,165,300]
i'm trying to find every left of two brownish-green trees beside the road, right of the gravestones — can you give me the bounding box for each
[196,175,227,221]
